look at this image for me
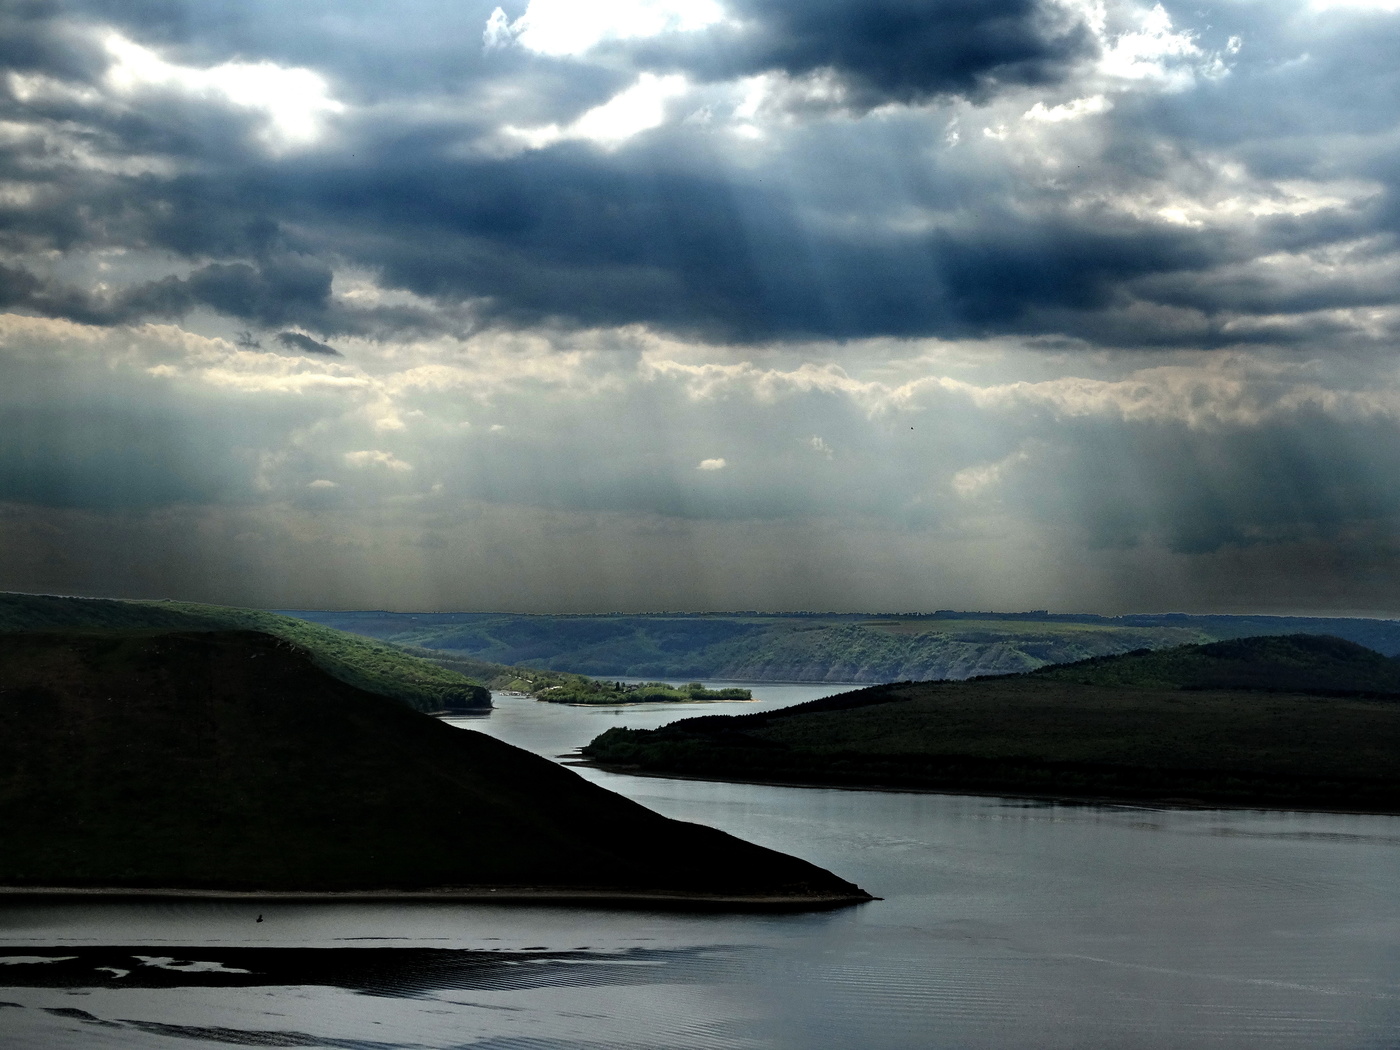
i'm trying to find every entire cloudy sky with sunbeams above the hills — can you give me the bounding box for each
[0,0,1400,615]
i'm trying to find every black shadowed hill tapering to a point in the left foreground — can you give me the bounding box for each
[0,631,867,907]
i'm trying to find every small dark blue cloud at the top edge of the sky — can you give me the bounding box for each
[636,0,1095,108]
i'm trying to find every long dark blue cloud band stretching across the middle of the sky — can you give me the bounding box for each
[90,147,1226,339]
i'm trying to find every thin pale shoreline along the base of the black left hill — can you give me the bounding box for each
[0,885,882,911]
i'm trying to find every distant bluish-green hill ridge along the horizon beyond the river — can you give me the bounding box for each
[278,612,1400,683]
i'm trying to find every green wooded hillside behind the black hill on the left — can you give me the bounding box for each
[0,592,491,711]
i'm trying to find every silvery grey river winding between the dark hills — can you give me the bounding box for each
[0,683,1400,1050]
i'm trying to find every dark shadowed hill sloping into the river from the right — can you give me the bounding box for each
[584,636,1400,812]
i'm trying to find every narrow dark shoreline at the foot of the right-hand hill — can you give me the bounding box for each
[560,753,1400,816]
